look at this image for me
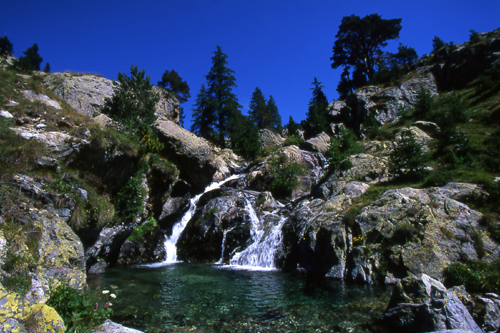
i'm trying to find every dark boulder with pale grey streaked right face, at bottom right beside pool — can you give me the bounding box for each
[382,274,483,333]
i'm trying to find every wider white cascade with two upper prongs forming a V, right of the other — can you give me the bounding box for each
[229,200,286,269]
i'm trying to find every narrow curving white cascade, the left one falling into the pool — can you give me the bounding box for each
[164,175,241,263]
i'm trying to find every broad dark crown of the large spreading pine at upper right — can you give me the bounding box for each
[330,14,401,83]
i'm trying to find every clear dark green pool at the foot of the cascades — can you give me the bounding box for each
[88,264,390,332]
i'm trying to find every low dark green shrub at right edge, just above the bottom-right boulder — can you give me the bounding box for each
[445,260,500,293]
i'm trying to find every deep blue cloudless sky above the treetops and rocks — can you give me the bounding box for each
[0,0,500,128]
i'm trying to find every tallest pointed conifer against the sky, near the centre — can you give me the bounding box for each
[205,46,241,147]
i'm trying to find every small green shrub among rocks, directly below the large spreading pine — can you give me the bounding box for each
[325,128,364,171]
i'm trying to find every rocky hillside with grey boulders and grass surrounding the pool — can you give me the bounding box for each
[0,30,500,332]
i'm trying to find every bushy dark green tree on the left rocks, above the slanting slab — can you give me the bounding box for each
[103,65,160,129]
